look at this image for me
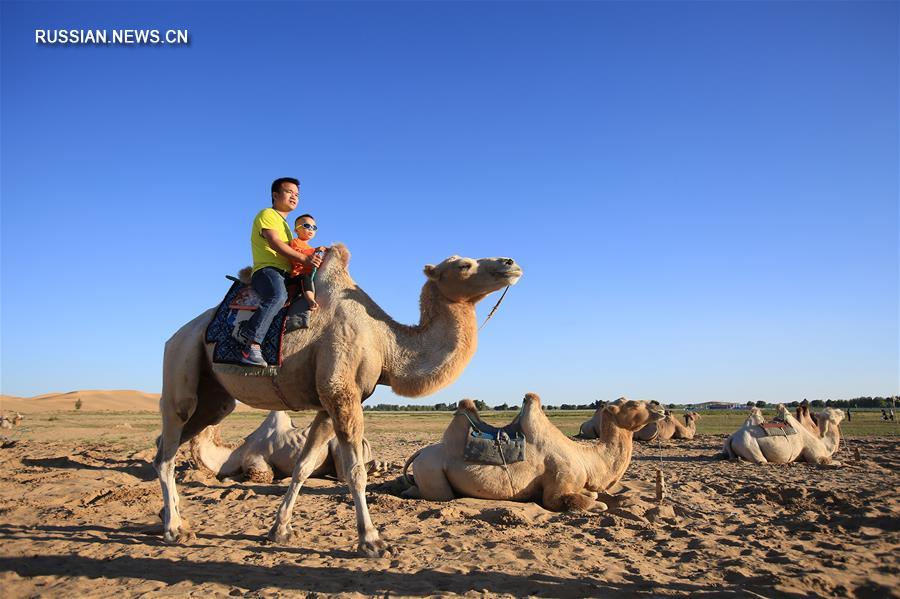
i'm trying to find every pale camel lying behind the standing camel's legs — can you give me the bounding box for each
[191,411,377,483]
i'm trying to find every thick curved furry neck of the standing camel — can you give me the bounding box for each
[385,281,478,397]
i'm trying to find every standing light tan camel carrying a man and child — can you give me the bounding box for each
[154,244,522,556]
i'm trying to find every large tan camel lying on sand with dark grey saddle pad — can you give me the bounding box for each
[404,393,663,511]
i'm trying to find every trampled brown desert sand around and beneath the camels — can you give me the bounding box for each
[0,392,900,598]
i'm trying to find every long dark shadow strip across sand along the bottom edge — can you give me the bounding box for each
[0,555,773,599]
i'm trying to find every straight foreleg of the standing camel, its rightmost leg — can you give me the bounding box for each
[334,401,390,557]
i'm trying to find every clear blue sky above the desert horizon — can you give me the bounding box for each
[0,1,900,404]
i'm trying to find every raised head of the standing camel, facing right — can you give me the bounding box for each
[425,256,522,304]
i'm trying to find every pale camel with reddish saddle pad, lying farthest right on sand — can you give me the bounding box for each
[724,404,844,466]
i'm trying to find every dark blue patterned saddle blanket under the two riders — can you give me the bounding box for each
[206,281,294,368]
